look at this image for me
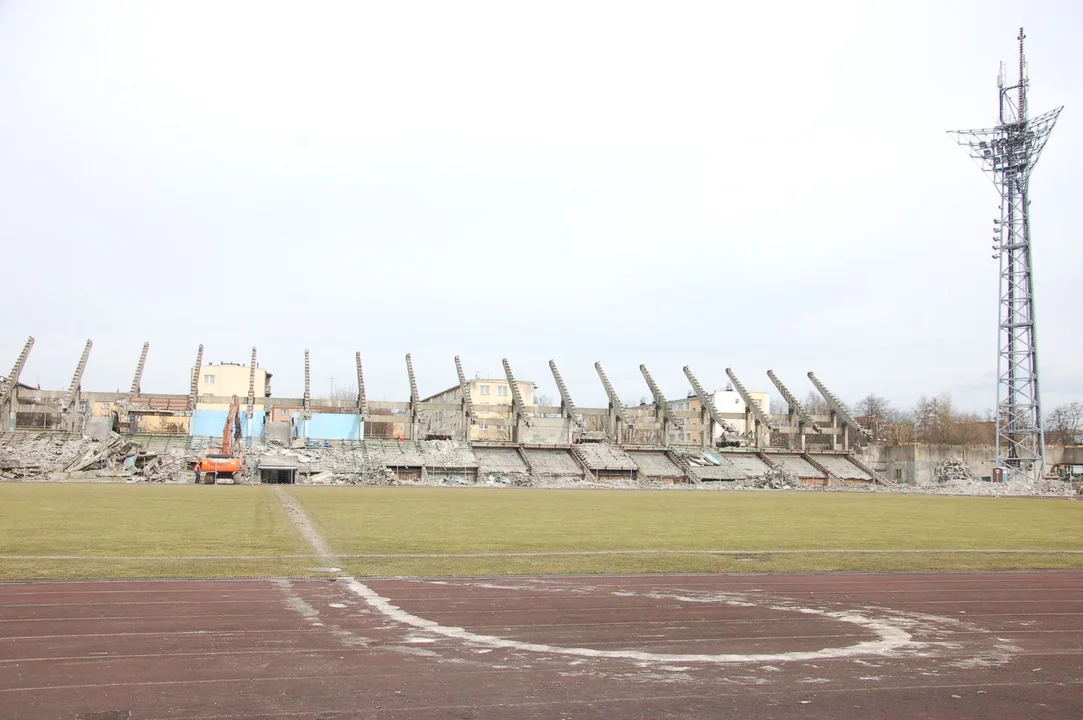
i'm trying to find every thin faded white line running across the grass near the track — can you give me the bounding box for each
[0,550,1083,562]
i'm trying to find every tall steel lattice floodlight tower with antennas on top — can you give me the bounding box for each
[951,28,1064,481]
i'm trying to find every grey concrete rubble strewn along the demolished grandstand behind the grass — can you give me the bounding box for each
[0,431,1074,496]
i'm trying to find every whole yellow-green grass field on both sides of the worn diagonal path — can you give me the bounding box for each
[0,484,1083,579]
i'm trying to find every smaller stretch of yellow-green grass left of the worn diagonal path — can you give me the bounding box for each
[0,483,313,579]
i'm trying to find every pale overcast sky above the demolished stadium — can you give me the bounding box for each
[0,0,1083,411]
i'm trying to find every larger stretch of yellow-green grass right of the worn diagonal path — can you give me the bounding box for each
[290,487,1083,575]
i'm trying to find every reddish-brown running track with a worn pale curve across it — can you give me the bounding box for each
[0,572,1083,720]
